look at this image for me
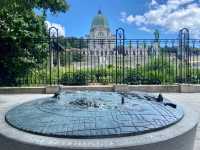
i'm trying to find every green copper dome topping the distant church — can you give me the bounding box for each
[91,10,109,29]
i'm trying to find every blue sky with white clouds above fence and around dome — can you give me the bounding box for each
[47,0,200,39]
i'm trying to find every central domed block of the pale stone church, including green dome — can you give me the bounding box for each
[87,10,115,55]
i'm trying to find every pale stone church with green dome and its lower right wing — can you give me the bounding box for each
[82,10,159,58]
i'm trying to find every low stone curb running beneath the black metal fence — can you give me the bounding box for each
[0,84,200,94]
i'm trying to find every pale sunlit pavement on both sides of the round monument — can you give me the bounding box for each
[0,93,200,150]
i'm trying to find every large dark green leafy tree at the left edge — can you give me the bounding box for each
[0,0,69,85]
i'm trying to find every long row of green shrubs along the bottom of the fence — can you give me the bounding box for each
[26,59,200,85]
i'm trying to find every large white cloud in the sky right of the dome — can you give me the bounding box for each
[121,0,200,38]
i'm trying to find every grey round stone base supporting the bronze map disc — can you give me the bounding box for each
[0,93,198,150]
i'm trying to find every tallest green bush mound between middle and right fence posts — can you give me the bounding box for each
[125,57,175,84]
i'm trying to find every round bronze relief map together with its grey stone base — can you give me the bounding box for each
[0,91,197,150]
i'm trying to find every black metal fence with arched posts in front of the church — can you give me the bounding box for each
[1,29,200,86]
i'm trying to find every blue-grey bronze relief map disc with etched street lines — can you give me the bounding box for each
[6,92,184,138]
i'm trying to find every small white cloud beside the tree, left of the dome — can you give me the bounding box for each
[45,21,65,36]
